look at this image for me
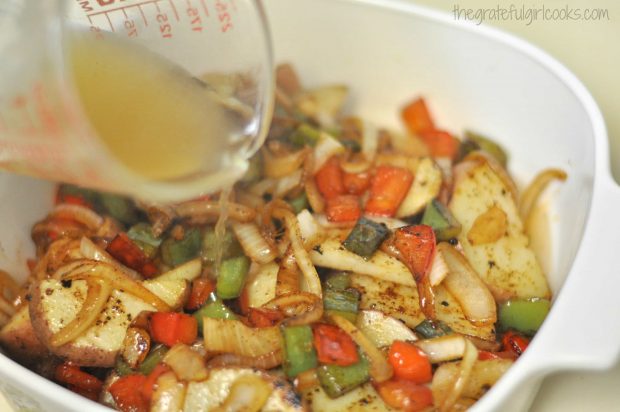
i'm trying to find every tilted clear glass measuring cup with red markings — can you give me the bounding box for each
[0,0,273,201]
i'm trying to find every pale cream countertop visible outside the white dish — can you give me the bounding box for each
[0,0,620,412]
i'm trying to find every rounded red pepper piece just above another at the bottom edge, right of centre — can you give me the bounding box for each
[388,340,433,384]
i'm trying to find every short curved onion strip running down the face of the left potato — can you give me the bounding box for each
[50,277,112,347]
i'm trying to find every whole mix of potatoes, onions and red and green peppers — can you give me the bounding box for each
[0,65,566,412]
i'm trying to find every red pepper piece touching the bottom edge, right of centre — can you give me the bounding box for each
[377,379,433,412]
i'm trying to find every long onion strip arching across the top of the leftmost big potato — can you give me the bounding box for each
[62,259,171,312]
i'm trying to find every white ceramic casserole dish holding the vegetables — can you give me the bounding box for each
[0,0,620,411]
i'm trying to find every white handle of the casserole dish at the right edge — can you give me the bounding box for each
[532,176,620,371]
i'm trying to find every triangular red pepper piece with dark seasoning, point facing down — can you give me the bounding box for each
[394,225,436,282]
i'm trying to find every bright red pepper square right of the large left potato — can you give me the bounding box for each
[150,312,198,346]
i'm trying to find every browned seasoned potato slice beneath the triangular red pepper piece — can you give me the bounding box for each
[351,274,495,341]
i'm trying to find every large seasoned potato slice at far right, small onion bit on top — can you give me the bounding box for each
[449,158,550,302]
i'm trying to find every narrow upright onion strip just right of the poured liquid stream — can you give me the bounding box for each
[273,208,322,297]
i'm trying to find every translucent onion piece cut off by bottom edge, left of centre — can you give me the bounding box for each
[213,374,273,412]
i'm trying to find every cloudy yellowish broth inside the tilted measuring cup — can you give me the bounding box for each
[70,35,241,180]
